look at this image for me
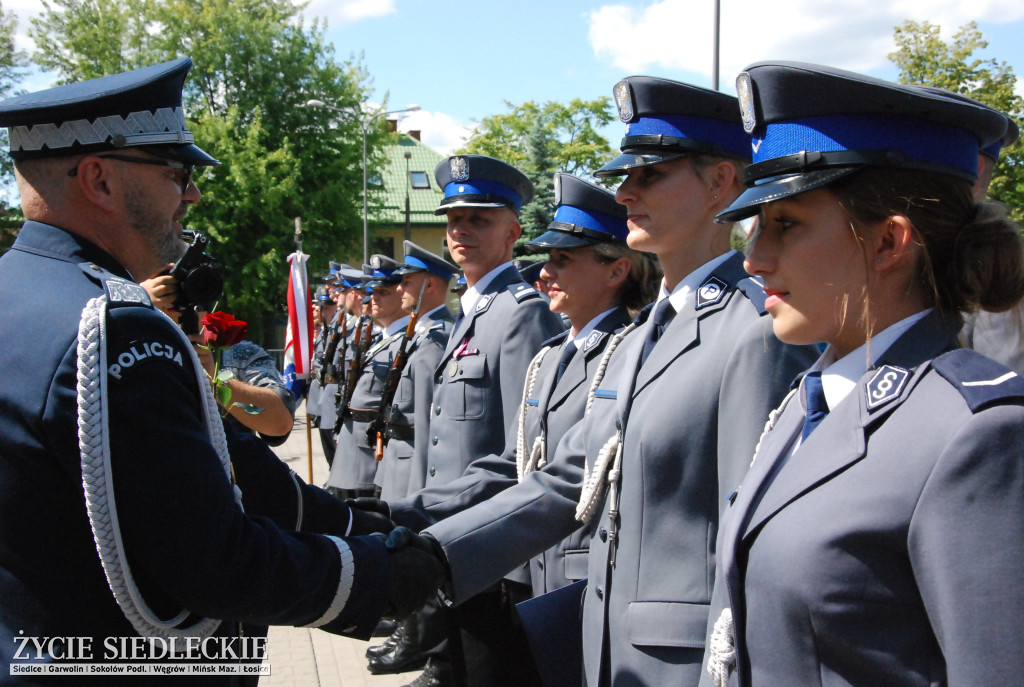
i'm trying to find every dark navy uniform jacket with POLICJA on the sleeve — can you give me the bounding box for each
[0,221,390,685]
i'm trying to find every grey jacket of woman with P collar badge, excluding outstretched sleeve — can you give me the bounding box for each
[566,254,816,687]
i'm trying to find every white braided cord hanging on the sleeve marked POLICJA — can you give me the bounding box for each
[77,296,241,638]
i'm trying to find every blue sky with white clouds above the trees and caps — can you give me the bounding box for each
[3,0,1024,153]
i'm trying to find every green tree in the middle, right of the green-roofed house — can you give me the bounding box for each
[459,97,614,245]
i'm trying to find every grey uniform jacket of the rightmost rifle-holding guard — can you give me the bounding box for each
[377,305,455,501]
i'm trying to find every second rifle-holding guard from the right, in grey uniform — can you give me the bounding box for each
[327,255,410,499]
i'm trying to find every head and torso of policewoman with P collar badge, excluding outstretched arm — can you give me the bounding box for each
[577,77,814,686]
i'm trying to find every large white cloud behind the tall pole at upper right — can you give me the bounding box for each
[588,0,1024,85]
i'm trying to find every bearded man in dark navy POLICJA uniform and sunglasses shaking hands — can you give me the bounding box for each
[0,58,440,684]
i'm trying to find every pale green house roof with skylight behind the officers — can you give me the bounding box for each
[371,133,445,226]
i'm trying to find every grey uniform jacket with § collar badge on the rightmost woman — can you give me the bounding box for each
[713,312,1024,687]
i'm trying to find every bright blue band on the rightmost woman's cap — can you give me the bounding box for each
[752,115,978,175]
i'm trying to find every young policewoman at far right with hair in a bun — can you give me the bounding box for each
[709,62,1024,687]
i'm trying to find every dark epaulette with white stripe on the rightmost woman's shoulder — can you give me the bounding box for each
[932,348,1024,413]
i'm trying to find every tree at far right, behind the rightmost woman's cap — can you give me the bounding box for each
[889,22,1024,222]
